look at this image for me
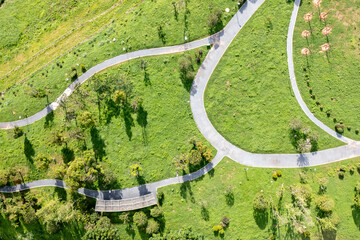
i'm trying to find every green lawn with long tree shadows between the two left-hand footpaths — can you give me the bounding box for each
[0,47,216,189]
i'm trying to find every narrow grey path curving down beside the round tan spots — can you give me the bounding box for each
[287,0,354,143]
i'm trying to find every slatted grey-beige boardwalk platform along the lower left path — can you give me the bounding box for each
[95,192,157,212]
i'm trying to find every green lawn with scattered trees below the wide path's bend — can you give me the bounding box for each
[109,158,360,240]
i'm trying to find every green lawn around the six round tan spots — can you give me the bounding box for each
[294,0,360,140]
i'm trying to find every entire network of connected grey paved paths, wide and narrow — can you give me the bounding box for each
[0,0,360,200]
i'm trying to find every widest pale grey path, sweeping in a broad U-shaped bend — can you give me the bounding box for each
[190,0,360,168]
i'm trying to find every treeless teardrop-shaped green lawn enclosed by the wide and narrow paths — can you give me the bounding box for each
[205,0,341,153]
